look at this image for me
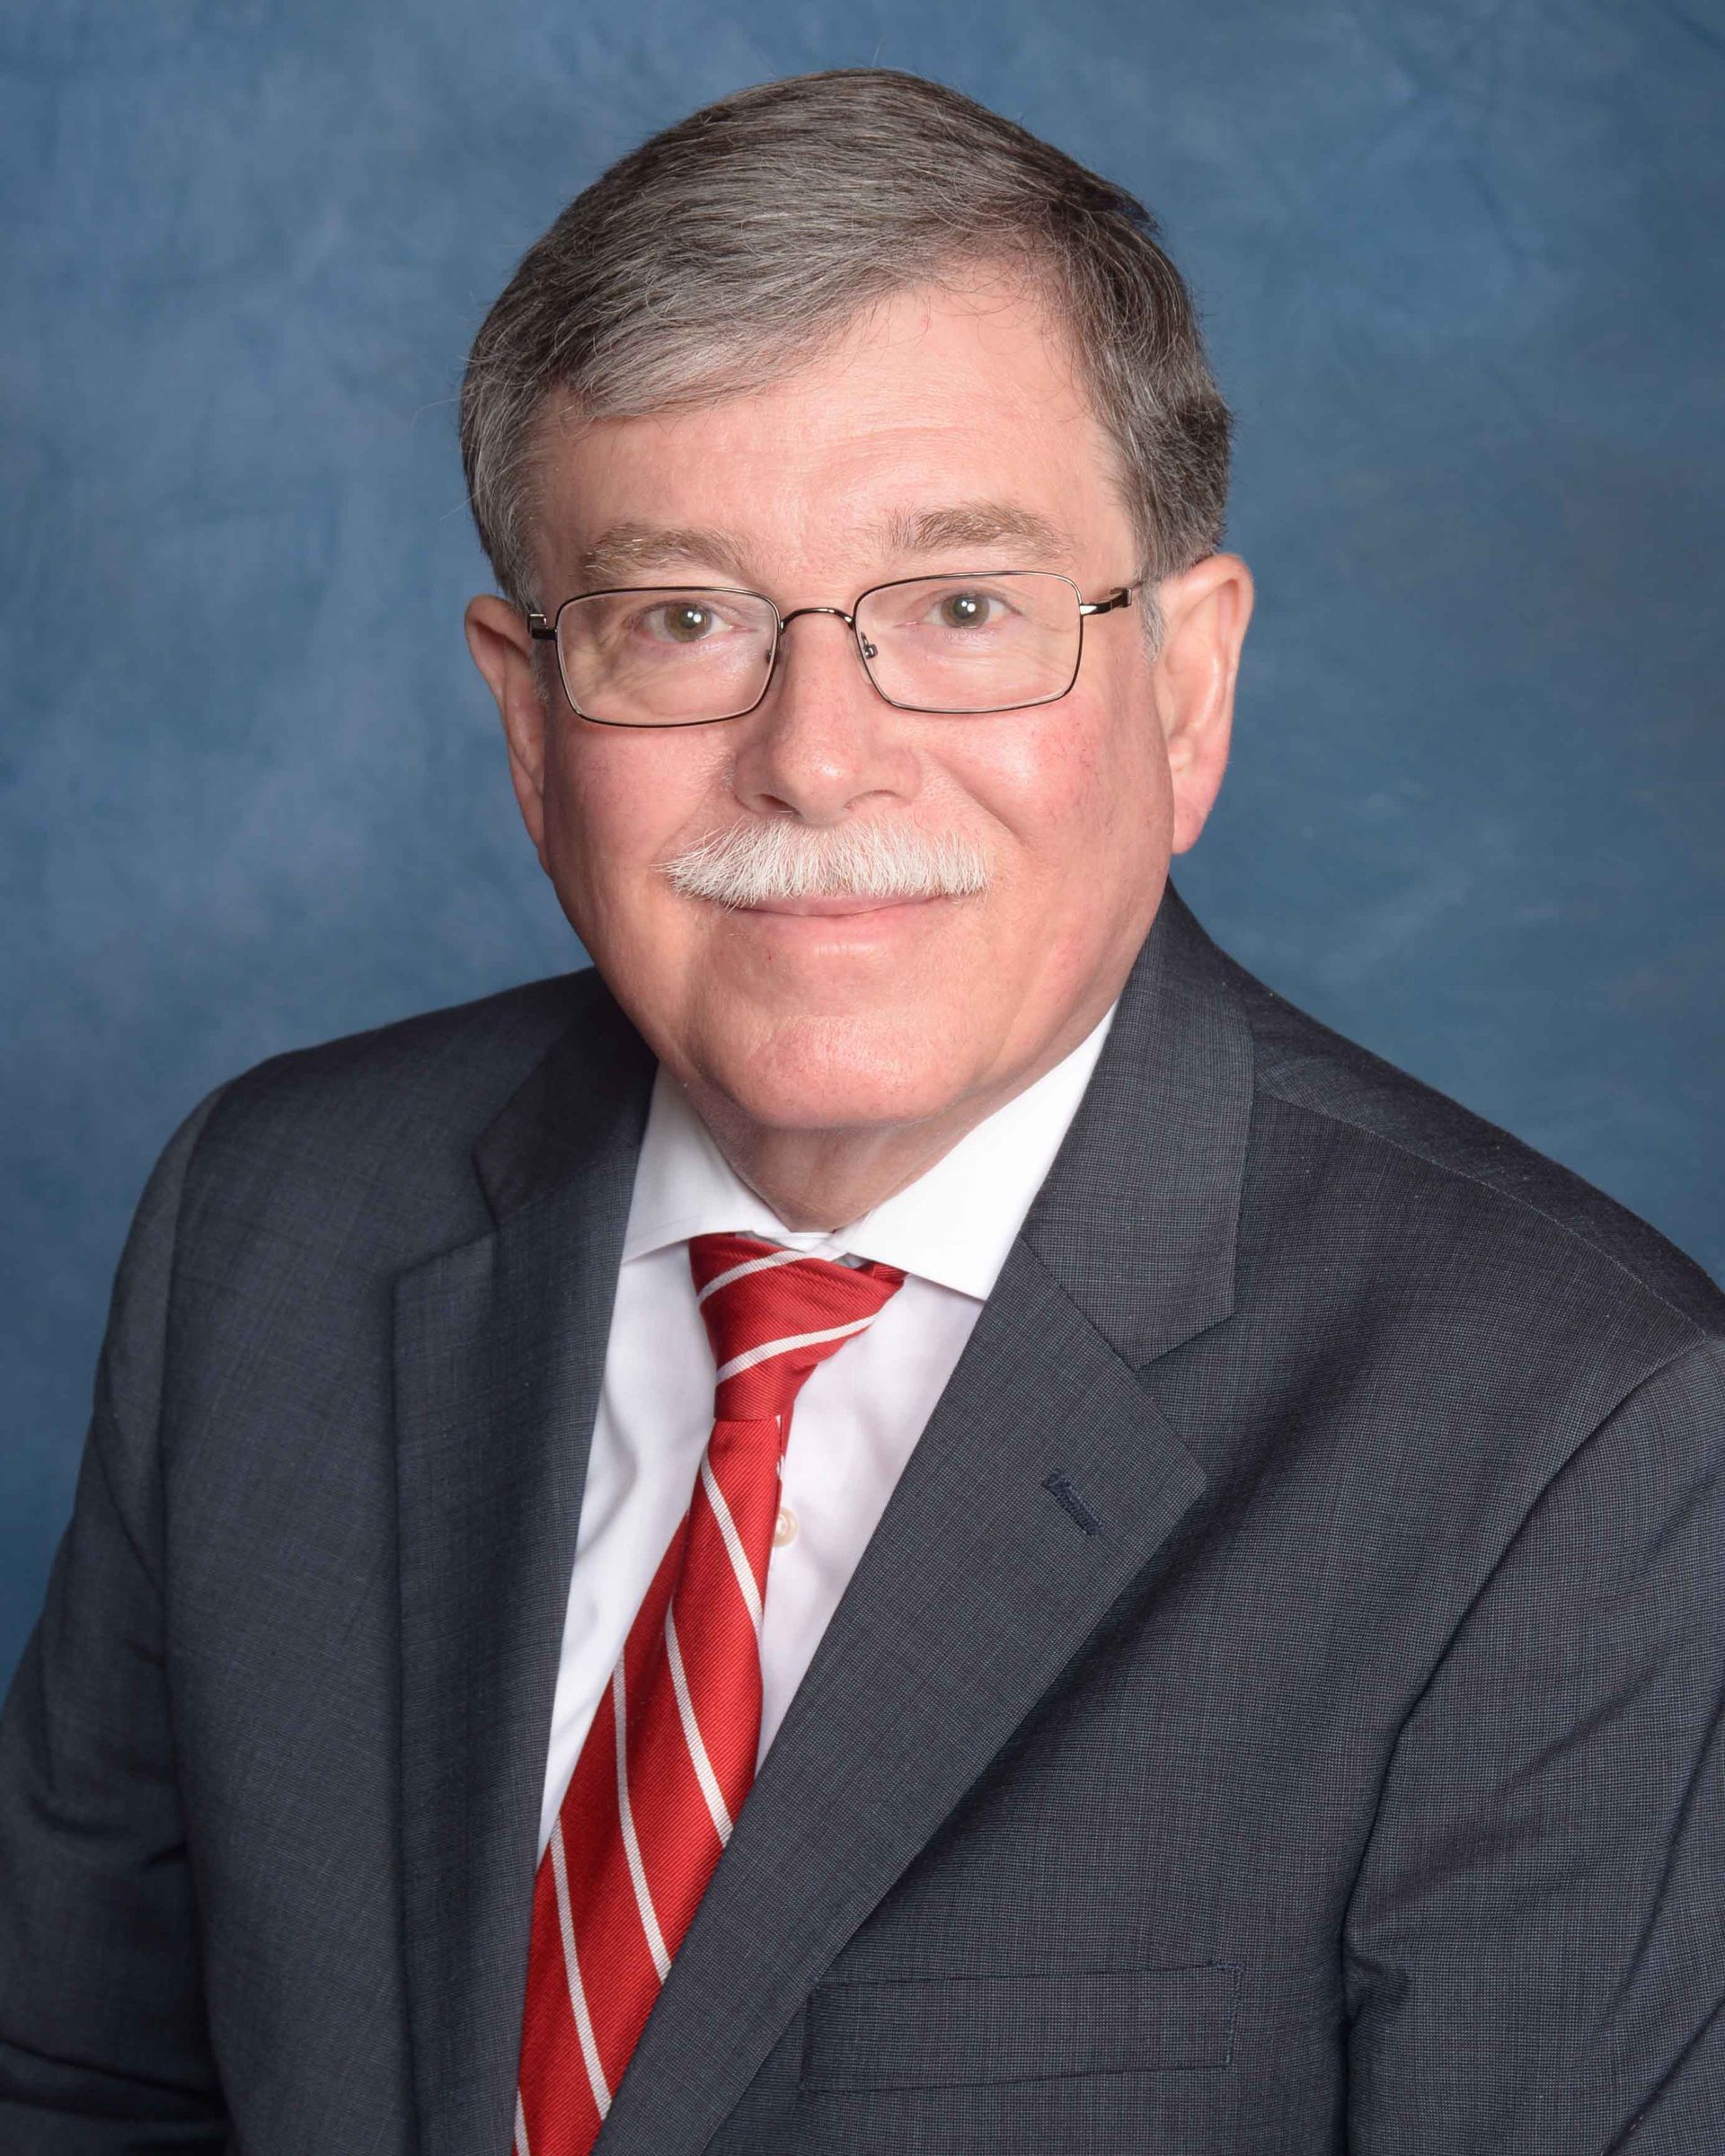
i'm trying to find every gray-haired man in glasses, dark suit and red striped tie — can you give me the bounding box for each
[0,71,1725,2156]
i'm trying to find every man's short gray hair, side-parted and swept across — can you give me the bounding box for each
[462,66,1229,634]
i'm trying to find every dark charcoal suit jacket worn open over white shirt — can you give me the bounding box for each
[0,893,1725,2156]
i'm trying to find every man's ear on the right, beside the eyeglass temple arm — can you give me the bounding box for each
[1152,554,1252,853]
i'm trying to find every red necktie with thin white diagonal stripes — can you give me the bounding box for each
[516,1235,904,2156]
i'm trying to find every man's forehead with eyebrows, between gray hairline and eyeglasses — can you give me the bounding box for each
[533,282,1130,591]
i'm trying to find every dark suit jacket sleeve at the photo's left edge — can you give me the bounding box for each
[0,1100,226,2156]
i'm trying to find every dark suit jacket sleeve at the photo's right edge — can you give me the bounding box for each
[1346,1343,1725,2156]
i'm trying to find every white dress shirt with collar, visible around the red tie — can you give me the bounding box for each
[539,1009,1115,1852]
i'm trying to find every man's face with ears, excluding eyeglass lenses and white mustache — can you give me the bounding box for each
[470,282,1246,1132]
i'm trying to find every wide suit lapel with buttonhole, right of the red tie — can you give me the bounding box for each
[599,890,1251,2156]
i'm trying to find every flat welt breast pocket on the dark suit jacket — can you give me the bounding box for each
[802,1962,1240,2093]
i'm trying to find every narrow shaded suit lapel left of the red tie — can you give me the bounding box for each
[397,979,651,2156]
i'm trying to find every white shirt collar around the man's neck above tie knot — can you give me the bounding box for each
[624,1007,1115,1303]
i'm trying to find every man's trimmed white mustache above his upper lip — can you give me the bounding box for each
[659,815,994,906]
